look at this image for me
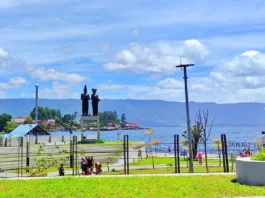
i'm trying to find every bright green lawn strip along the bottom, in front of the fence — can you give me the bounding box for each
[0,175,265,198]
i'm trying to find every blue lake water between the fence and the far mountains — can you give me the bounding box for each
[52,126,265,153]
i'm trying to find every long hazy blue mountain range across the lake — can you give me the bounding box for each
[0,99,265,126]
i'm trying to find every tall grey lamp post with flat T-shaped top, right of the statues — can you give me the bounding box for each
[176,64,194,173]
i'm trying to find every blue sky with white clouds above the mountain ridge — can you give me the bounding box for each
[0,0,265,103]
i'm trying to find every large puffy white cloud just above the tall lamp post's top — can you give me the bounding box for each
[104,40,209,73]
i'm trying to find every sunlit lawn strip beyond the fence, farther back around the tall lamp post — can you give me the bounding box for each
[130,156,222,166]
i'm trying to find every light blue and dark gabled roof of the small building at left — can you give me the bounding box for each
[8,124,51,137]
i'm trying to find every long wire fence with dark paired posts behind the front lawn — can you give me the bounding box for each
[0,135,257,178]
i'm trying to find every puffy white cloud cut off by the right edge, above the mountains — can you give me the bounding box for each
[210,51,265,89]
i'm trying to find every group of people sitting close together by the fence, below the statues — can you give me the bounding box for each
[81,157,102,175]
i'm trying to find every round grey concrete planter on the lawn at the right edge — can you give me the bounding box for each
[236,157,265,186]
